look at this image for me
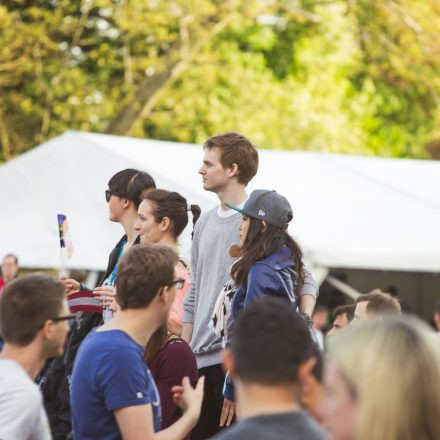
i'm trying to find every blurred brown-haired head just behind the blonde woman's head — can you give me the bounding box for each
[350,289,402,325]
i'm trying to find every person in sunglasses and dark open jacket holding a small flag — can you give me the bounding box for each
[37,169,156,440]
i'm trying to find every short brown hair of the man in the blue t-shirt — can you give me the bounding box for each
[115,244,179,310]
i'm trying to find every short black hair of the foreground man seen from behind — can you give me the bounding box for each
[231,298,315,386]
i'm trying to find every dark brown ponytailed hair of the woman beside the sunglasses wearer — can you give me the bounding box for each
[141,189,201,239]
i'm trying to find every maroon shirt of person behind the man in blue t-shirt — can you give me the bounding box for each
[149,338,198,439]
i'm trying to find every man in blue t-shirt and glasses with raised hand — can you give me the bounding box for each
[71,244,203,440]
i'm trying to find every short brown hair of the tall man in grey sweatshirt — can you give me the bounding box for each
[203,131,258,185]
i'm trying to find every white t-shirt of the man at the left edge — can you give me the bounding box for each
[0,359,52,440]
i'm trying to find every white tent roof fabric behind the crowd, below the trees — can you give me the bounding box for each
[0,131,440,272]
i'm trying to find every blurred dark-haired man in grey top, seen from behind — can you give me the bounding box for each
[213,297,325,440]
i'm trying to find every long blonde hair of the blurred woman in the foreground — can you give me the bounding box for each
[330,316,440,440]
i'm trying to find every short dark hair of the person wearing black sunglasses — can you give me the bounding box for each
[108,168,156,209]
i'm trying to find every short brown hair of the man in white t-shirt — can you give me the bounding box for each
[0,274,66,347]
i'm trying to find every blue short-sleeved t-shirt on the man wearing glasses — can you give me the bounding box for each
[71,330,161,440]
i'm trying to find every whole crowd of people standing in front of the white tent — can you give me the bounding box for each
[0,132,440,440]
